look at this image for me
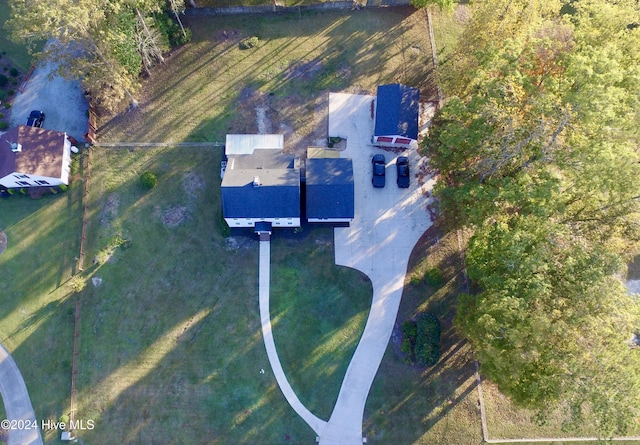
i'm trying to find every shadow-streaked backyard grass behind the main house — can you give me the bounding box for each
[98,8,431,144]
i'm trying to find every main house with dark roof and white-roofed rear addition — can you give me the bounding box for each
[221,135,300,230]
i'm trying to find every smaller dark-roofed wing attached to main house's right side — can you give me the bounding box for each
[306,158,355,223]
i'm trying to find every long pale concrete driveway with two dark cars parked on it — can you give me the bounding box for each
[318,94,433,445]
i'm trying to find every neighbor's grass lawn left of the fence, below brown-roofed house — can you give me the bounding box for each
[0,163,82,437]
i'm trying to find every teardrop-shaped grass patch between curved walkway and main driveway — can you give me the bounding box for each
[271,232,373,420]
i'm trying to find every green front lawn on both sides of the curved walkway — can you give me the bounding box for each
[68,148,371,444]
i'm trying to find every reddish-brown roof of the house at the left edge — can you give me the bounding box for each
[0,125,67,178]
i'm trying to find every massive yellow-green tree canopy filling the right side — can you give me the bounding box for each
[423,0,640,435]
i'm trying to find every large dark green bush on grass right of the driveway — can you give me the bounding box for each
[401,312,440,366]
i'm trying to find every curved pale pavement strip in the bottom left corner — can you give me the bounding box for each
[0,345,43,445]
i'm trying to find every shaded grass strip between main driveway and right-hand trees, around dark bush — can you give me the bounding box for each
[364,228,482,445]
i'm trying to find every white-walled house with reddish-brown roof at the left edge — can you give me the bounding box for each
[0,125,71,188]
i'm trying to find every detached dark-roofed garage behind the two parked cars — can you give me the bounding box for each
[372,84,420,148]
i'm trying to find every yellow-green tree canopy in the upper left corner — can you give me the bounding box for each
[5,0,186,110]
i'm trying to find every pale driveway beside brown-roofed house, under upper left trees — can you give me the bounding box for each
[11,57,89,141]
